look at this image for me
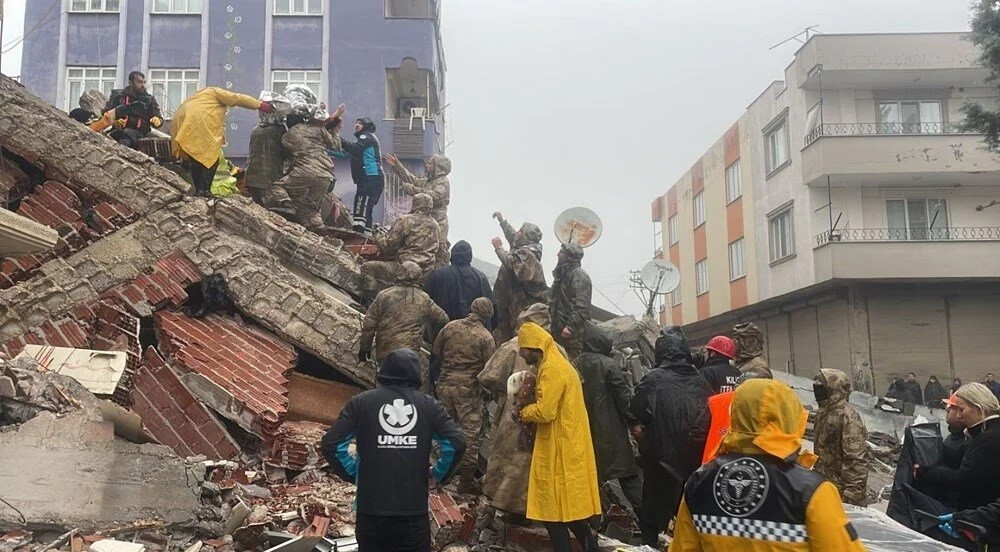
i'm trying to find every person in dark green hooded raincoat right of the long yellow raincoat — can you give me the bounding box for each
[573,325,642,517]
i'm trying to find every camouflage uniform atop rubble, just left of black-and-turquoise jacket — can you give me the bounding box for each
[264,123,340,230]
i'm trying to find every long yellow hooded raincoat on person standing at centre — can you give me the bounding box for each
[517,322,601,521]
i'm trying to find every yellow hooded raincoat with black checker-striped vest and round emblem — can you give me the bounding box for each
[669,379,865,552]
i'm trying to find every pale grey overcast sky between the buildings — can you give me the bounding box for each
[2,0,968,314]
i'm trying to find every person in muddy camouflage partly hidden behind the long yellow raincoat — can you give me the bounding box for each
[477,303,549,518]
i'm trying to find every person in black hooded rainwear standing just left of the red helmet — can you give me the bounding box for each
[629,326,712,547]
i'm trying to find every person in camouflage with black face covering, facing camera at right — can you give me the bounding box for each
[813,369,871,506]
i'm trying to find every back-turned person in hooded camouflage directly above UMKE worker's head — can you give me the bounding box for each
[358,261,448,390]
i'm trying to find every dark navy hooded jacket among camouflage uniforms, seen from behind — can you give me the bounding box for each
[424,241,500,330]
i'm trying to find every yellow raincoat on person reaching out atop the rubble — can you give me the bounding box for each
[170,86,260,167]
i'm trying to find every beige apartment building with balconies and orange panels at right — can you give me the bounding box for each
[653,33,1000,392]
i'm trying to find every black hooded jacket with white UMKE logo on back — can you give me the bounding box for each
[322,349,465,516]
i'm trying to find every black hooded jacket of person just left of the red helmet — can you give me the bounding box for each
[629,326,712,482]
